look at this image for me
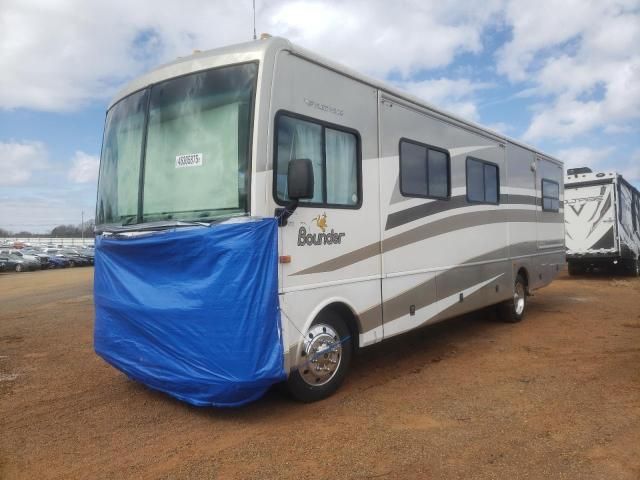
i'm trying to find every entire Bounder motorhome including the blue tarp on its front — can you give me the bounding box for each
[95,37,565,405]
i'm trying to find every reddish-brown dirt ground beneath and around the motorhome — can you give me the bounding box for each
[0,268,640,480]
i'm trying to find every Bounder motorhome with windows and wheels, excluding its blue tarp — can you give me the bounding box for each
[96,38,564,401]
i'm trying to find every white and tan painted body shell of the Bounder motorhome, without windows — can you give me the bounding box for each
[104,38,565,386]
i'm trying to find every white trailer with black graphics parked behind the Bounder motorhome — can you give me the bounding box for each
[564,167,640,276]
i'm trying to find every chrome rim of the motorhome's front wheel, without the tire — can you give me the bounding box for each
[298,324,342,387]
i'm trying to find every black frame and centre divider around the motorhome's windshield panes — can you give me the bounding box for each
[94,59,262,234]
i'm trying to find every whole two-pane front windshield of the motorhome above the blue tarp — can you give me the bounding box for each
[96,63,258,226]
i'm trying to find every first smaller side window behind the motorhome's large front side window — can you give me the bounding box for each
[400,139,451,198]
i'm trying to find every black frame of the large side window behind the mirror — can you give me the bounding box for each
[271,110,363,210]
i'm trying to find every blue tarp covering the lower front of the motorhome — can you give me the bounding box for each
[94,219,285,407]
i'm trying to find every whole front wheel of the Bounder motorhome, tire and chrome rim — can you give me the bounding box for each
[287,311,353,403]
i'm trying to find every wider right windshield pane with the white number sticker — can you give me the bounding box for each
[143,63,258,221]
